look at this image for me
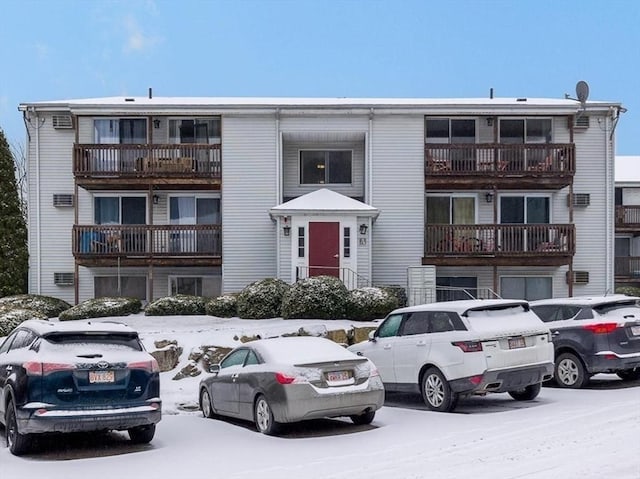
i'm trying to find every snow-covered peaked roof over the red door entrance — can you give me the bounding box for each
[269,188,380,219]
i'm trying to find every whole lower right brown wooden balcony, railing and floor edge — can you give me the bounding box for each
[422,224,576,266]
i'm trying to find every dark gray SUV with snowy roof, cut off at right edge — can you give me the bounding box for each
[530,295,640,389]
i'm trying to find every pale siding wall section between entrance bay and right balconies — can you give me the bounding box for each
[369,115,424,286]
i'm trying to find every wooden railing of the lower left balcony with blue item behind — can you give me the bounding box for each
[73,225,222,259]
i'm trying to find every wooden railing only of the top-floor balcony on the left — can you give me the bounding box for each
[73,144,222,178]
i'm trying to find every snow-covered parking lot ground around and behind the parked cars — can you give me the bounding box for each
[0,315,640,479]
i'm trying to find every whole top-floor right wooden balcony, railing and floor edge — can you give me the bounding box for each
[425,143,575,190]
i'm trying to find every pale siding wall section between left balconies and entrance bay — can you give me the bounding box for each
[222,116,278,292]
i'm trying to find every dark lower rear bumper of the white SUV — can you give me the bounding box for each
[449,362,554,394]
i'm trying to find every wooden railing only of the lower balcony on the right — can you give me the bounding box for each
[424,224,575,258]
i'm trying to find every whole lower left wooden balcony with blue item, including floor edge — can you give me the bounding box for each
[73,225,222,266]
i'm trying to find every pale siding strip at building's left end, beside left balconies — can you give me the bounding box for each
[28,113,75,303]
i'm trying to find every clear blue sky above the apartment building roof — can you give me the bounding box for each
[0,0,640,155]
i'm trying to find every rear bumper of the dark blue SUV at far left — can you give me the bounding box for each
[16,399,162,434]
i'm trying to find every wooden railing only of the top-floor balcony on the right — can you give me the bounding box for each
[425,143,575,176]
